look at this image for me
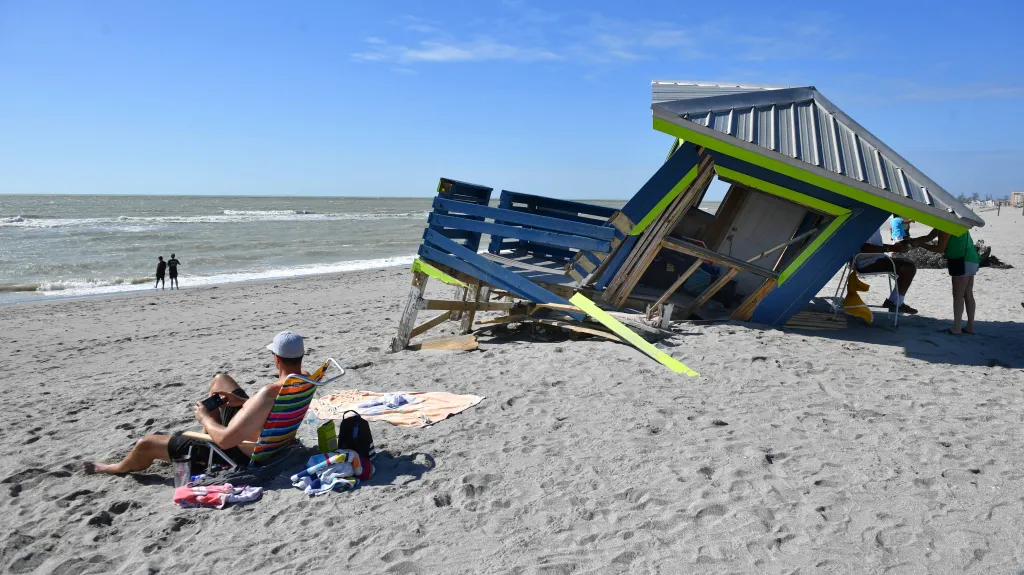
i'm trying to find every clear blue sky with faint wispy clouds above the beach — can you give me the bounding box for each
[0,0,1024,198]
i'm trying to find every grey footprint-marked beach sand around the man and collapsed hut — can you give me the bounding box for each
[0,211,1024,573]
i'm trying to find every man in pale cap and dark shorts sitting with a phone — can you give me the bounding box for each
[85,331,308,475]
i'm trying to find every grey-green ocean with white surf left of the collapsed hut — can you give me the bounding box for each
[0,195,655,304]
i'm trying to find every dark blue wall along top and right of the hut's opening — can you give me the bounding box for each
[712,151,889,326]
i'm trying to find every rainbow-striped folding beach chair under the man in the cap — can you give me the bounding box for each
[181,357,345,471]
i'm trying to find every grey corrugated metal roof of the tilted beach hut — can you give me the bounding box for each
[651,82,985,227]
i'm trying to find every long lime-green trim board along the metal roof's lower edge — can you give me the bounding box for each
[653,118,968,235]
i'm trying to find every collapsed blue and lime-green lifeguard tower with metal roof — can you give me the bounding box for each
[392,82,984,366]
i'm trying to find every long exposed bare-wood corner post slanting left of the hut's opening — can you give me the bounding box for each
[603,150,715,308]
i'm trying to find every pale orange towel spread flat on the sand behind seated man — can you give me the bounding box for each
[309,390,483,428]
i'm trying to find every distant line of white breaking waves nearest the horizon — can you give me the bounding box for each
[0,210,429,231]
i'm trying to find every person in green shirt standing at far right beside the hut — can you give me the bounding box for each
[914,226,981,336]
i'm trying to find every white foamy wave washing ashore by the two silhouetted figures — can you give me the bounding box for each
[0,256,416,298]
